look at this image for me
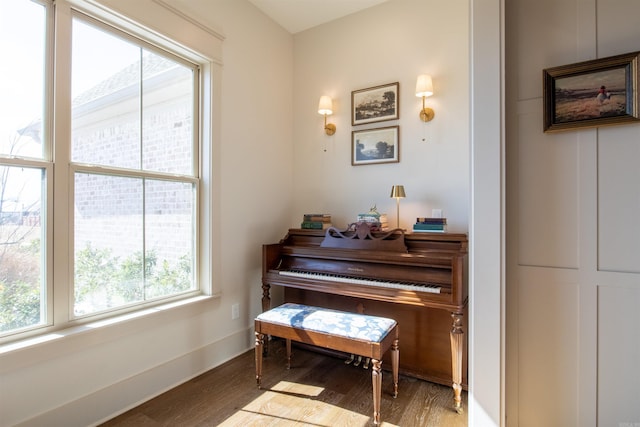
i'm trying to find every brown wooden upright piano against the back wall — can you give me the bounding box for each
[262,223,468,412]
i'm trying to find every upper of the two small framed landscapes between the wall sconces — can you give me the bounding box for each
[351,82,400,126]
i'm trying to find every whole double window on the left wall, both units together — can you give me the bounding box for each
[0,0,199,335]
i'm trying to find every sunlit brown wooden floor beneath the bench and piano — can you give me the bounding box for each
[103,340,467,427]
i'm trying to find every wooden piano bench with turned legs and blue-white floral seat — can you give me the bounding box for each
[255,303,400,425]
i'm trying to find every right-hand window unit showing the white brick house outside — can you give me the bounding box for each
[71,16,197,316]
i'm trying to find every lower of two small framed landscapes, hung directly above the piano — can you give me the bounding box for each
[351,126,400,166]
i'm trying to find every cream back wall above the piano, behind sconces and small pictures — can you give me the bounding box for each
[290,0,469,232]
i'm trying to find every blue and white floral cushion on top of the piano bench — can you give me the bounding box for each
[256,303,396,342]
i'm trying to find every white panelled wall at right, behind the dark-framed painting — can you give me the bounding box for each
[506,0,640,427]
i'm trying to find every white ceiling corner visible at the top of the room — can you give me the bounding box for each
[249,0,389,34]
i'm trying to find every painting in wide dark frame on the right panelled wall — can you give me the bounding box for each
[542,52,640,132]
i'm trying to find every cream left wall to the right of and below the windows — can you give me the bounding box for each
[0,0,293,426]
